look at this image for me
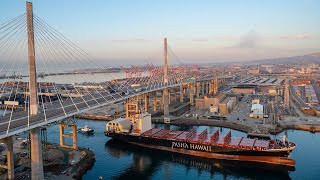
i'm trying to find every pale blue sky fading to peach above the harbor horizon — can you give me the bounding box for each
[0,0,320,65]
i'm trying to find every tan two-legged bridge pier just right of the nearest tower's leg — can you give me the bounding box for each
[59,122,78,149]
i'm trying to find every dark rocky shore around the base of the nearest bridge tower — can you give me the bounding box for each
[0,143,95,180]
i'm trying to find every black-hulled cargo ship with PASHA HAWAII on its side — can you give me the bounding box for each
[105,113,296,166]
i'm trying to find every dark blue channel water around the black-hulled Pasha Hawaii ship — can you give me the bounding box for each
[47,120,320,180]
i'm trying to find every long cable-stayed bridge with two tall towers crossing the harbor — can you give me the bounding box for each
[0,3,229,179]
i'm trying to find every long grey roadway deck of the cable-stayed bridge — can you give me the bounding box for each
[0,76,225,139]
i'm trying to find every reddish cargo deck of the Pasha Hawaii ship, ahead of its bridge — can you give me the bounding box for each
[141,128,270,150]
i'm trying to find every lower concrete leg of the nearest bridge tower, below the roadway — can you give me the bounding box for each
[30,127,44,180]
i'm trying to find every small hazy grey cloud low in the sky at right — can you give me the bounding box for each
[232,30,259,48]
